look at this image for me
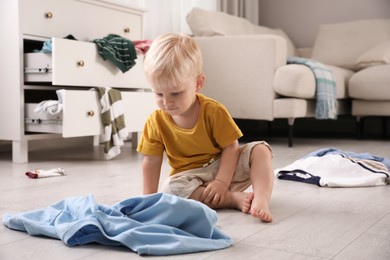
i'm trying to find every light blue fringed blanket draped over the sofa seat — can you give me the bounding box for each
[287,56,337,119]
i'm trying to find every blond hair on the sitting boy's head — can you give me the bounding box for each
[144,33,202,88]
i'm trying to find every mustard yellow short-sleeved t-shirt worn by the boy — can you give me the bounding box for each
[137,94,242,175]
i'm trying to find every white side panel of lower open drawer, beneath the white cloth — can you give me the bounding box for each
[25,103,62,133]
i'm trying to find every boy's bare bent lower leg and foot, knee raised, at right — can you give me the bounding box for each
[249,144,274,222]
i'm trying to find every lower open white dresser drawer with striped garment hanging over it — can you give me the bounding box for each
[25,90,156,137]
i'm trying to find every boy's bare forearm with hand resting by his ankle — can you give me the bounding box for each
[200,140,240,204]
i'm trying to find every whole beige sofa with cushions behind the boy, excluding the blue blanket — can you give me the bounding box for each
[187,8,390,146]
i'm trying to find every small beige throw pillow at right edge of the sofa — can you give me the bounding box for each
[355,41,390,68]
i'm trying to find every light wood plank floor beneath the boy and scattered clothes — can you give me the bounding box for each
[0,139,390,260]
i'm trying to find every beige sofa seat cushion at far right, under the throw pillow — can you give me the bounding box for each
[348,64,390,100]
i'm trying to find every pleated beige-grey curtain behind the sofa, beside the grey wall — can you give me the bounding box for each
[217,0,259,24]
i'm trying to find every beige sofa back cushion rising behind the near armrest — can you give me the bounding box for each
[187,7,295,55]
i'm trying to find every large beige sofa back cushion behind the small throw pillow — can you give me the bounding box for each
[311,19,390,69]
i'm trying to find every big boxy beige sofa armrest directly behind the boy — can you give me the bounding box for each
[195,35,287,120]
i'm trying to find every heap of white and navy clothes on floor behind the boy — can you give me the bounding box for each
[275,148,390,187]
